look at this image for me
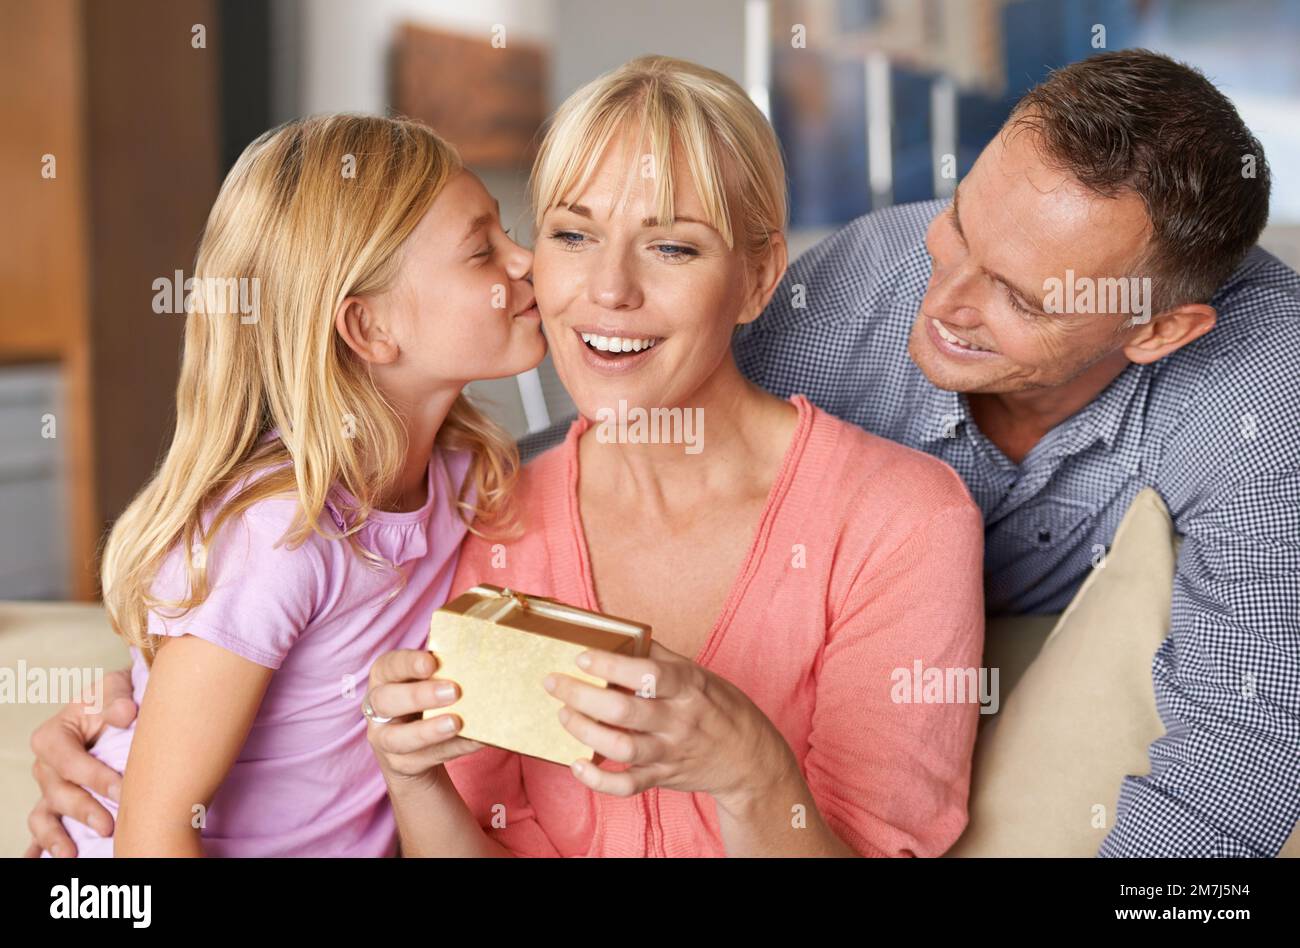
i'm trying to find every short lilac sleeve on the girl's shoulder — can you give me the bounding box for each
[148,503,325,668]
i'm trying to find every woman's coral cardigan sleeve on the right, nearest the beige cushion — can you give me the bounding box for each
[803,502,984,856]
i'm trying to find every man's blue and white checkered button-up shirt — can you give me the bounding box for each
[521,202,1300,857]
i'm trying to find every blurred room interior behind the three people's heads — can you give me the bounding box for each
[0,0,1300,599]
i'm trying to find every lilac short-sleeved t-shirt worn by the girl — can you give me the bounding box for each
[64,439,471,856]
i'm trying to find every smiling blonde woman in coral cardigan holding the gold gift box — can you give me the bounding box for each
[371,57,983,856]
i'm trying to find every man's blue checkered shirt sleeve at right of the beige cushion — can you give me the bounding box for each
[1099,465,1300,857]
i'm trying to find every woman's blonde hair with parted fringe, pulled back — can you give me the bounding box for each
[529,56,787,266]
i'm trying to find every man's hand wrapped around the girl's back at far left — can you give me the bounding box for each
[25,670,138,857]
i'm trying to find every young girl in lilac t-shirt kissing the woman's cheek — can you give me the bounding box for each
[44,116,546,856]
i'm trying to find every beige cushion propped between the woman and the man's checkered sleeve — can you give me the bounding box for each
[946,488,1300,857]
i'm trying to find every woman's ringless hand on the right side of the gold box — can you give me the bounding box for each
[543,642,798,810]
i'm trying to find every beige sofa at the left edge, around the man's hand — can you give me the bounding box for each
[0,602,130,857]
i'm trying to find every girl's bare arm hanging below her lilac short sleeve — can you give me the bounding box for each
[113,635,274,856]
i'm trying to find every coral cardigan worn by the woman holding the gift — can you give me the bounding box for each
[447,395,984,856]
